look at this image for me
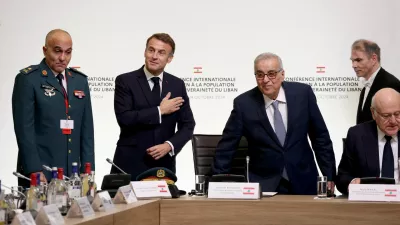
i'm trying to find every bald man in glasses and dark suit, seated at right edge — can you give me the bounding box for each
[337,88,400,194]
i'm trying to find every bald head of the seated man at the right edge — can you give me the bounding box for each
[371,88,400,136]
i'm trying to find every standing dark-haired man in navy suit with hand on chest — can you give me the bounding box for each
[111,33,195,180]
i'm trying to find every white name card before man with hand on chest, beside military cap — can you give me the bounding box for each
[131,180,171,199]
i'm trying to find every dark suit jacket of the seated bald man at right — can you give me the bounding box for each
[336,121,400,194]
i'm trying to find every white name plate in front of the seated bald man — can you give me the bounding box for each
[349,184,400,202]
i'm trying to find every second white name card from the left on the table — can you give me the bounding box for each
[35,204,64,225]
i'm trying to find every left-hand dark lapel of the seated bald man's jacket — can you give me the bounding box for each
[363,123,380,177]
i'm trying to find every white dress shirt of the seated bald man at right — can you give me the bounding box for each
[377,127,399,184]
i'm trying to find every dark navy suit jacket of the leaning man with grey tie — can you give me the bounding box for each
[213,82,336,194]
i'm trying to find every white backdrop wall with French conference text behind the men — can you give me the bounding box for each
[0,0,400,193]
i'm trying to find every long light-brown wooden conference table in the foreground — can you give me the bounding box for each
[62,195,400,225]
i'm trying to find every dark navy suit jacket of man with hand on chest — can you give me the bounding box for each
[111,67,195,180]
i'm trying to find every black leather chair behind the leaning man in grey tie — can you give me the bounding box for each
[192,134,248,176]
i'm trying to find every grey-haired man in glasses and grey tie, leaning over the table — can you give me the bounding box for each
[213,53,336,194]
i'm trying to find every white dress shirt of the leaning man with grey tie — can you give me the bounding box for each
[263,86,287,131]
